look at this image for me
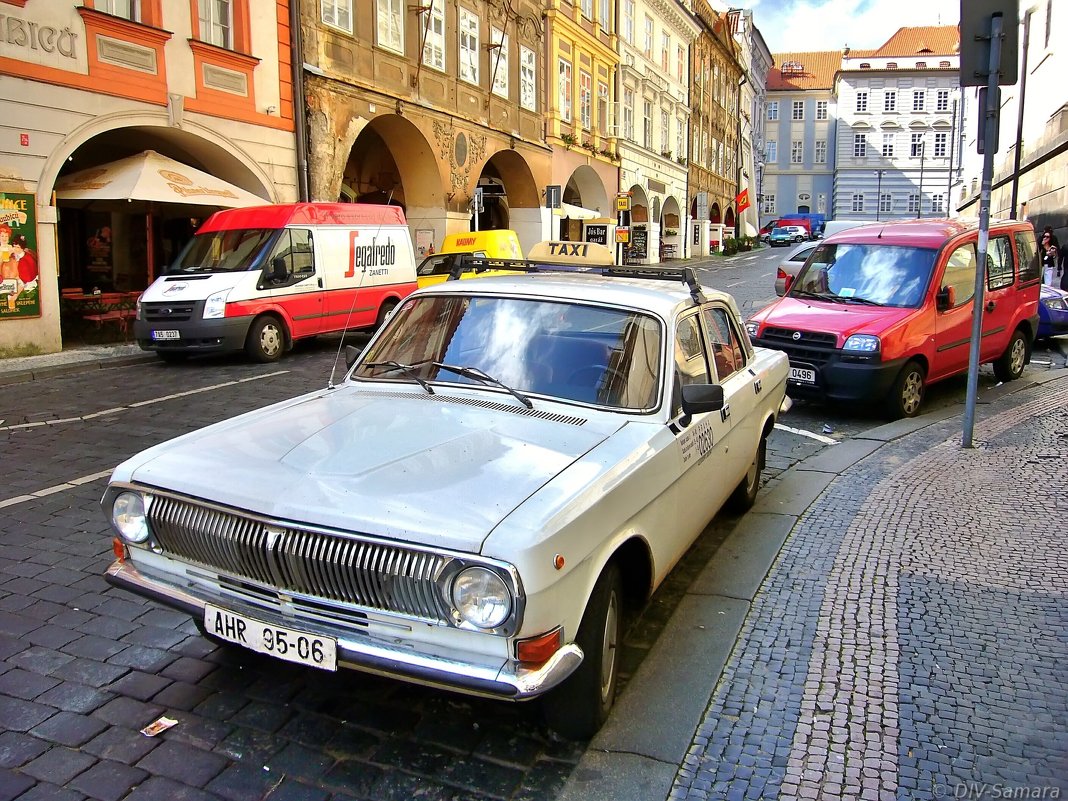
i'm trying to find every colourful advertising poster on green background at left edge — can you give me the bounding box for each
[0,192,41,321]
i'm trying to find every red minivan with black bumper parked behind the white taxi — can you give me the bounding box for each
[747,220,1041,419]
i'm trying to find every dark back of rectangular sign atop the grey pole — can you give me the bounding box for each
[960,0,1020,87]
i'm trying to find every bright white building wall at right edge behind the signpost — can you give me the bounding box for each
[954,0,1068,248]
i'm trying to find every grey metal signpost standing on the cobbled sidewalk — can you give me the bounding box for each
[961,14,1015,447]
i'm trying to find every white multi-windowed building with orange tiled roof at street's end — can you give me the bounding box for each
[832,26,961,222]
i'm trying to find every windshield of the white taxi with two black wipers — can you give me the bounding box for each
[352,295,662,411]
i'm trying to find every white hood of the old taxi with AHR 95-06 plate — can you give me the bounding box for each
[112,384,618,552]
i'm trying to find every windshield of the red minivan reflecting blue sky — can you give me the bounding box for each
[788,245,936,308]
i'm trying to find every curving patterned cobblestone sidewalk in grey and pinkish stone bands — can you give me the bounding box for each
[671,381,1068,801]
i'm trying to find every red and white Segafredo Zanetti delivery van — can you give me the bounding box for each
[134,203,417,362]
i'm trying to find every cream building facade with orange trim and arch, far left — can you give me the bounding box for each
[0,0,298,355]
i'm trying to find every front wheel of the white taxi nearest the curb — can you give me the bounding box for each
[543,562,623,740]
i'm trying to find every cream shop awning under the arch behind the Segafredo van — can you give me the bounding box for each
[56,151,270,208]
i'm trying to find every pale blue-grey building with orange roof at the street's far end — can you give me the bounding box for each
[760,51,842,226]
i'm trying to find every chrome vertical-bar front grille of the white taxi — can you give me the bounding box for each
[148,494,453,623]
